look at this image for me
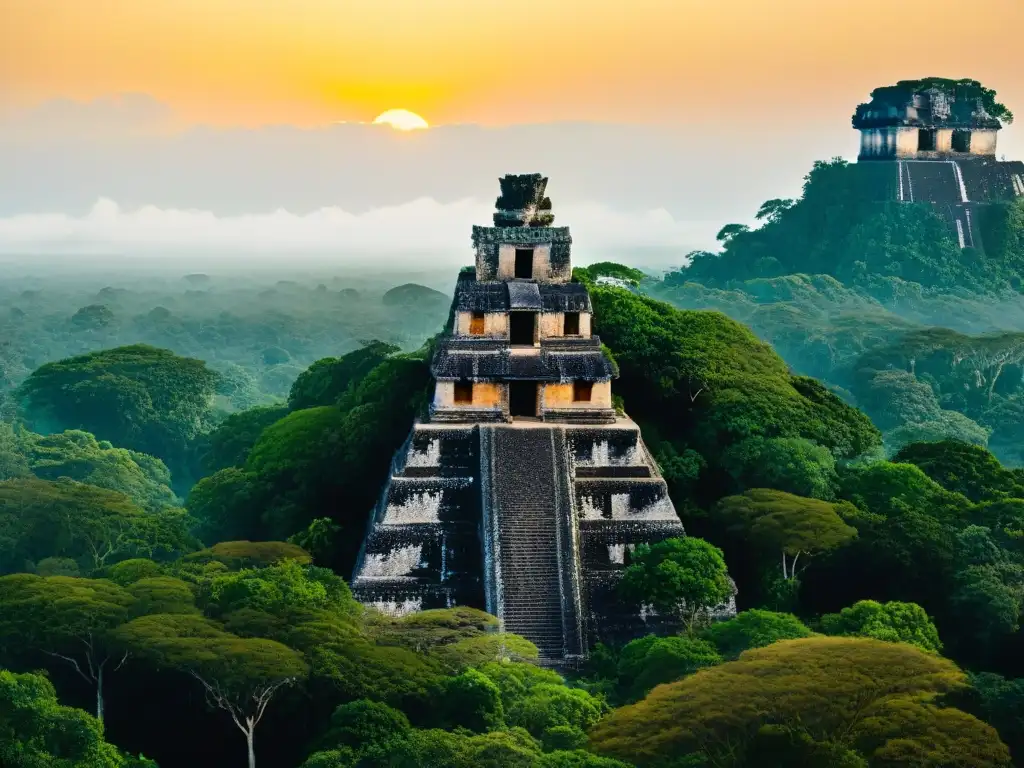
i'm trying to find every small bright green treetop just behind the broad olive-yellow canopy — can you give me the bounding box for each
[821,600,942,652]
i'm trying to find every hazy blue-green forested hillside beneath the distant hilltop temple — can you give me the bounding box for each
[642,152,1024,466]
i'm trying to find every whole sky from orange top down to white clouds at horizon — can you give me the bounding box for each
[0,0,1024,268]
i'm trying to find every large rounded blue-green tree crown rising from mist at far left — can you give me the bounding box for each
[22,344,217,481]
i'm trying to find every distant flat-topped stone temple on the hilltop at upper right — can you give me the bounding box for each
[853,78,1024,247]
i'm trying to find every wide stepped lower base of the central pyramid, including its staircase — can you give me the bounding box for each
[352,419,712,667]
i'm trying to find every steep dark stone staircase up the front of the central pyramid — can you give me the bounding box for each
[490,427,575,662]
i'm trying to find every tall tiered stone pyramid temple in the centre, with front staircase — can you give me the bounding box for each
[352,174,696,665]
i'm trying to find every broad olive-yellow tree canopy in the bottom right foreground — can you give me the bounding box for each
[591,637,1010,768]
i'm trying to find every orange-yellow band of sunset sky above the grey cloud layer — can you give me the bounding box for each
[0,0,1024,125]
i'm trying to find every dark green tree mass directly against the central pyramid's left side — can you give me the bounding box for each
[186,345,430,572]
